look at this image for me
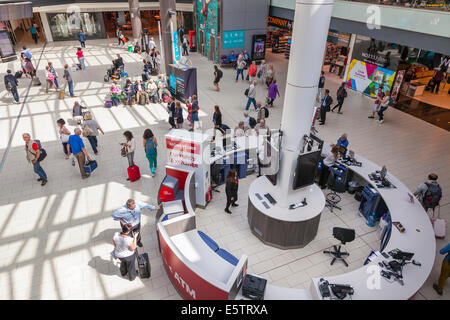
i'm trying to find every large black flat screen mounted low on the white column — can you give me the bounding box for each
[292,150,321,190]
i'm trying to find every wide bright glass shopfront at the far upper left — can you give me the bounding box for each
[47,12,106,41]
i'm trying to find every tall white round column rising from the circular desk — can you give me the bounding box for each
[275,0,333,206]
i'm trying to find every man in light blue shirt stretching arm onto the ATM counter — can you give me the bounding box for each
[111,199,161,247]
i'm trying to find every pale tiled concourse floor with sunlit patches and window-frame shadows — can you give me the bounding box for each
[0,41,450,299]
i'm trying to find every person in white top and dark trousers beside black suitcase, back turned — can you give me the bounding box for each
[112,223,139,281]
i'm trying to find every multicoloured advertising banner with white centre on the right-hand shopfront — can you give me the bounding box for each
[347,59,395,98]
